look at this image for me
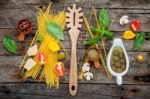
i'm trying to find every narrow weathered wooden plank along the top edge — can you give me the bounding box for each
[0,0,150,9]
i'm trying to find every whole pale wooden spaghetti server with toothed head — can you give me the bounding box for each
[66,4,83,96]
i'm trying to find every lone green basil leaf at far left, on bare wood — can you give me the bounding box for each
[3,36,17,53]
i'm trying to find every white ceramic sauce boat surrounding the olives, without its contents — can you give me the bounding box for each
[107,39,129,85]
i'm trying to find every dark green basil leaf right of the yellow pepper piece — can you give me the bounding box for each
[134,32,146,50]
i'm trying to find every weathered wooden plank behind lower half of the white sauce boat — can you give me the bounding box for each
[0,51,150,84]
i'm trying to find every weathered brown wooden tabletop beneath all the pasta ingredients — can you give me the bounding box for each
[0,0,150,99]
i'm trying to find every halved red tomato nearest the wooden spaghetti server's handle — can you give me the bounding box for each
[54,62,65,77]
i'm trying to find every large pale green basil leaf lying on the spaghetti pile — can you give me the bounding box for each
[47,22,64,40]
